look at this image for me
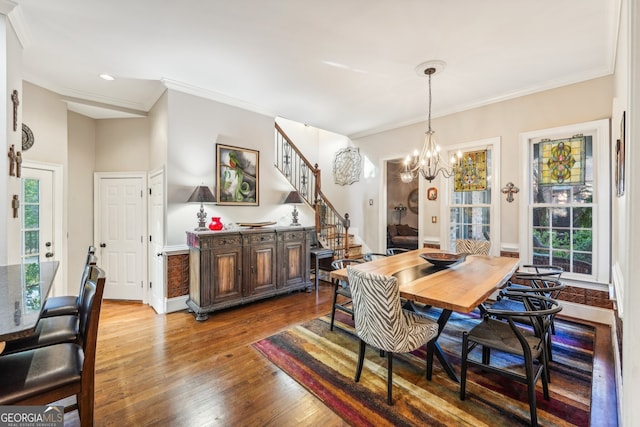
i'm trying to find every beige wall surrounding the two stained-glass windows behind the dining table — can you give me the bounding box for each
[350,77,613,252]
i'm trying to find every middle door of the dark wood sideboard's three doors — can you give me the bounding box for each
[244,233,277,297]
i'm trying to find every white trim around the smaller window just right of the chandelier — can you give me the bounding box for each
[440,136,502,256]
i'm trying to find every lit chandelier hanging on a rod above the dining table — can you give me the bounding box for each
[400,61,462,183]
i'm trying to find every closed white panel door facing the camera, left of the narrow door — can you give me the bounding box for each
[94,173,147,303]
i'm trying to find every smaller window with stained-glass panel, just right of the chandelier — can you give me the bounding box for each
[443,138,500,255]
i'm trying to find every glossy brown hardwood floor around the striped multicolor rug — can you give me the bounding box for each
[65,282,615,427]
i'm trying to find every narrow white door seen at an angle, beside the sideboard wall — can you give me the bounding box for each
[149,171,166,314]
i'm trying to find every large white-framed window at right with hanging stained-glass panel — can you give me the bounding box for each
[520,120,610,282]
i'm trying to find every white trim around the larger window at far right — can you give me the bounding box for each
[519,119,611,284]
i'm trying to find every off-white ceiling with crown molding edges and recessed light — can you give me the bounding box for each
[9,0,620,138]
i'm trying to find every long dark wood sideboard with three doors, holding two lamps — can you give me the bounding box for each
[187,227,313,321]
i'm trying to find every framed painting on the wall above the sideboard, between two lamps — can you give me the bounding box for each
[216,144,260,206]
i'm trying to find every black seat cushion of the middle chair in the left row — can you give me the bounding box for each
[3,316,79,354]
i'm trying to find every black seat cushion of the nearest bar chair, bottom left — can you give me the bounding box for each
[0,343,84,405]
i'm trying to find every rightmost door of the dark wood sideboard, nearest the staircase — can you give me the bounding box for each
[280,230,309,287]
